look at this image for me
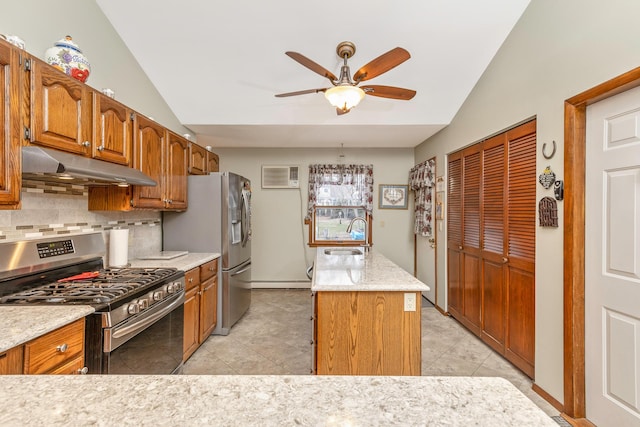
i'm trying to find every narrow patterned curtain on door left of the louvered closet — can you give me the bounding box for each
[409,159,436,236]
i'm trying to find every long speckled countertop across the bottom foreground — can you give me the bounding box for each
[0,375,557,427]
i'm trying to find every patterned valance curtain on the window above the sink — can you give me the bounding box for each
[307,164,373,218]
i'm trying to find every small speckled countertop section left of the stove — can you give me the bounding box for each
[0,305,94,352]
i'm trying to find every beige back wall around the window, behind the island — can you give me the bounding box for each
[213,147,414,282]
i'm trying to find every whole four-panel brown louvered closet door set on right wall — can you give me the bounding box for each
[447,121,537,378]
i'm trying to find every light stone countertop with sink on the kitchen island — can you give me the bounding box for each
[311,247,430,292]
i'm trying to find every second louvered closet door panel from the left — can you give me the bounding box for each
[461,145,482,334]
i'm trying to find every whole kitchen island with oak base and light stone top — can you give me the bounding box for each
[311,247,429,375]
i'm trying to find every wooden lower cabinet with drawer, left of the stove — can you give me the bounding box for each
[0,318,86,375]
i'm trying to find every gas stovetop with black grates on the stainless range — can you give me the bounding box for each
[0,268,179,304]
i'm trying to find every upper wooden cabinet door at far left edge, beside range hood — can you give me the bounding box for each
[0,43,22,209]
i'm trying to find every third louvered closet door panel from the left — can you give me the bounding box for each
[481,134,507,353]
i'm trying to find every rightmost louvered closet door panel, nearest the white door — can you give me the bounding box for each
[505,121,536,377]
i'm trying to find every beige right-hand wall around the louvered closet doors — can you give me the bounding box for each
[416,0,640,402]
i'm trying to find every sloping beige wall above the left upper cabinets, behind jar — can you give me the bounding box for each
[0,0,190,138]
